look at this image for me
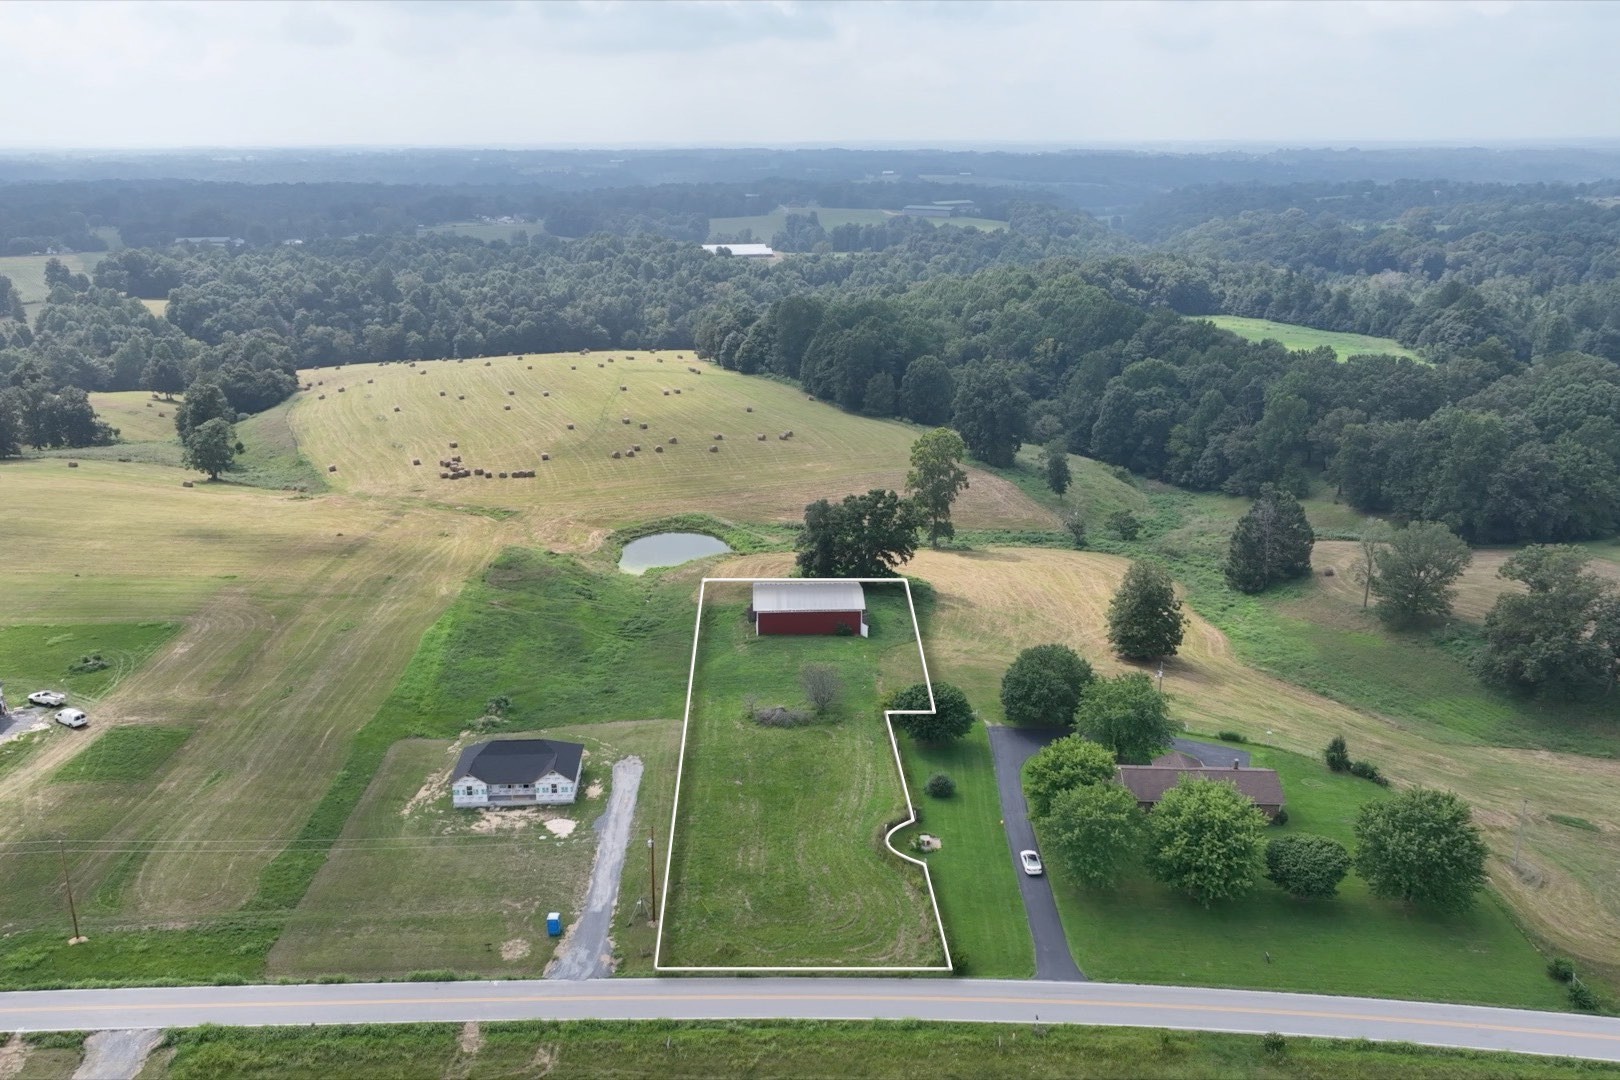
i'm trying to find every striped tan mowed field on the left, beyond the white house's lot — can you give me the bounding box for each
[0,458,507,926]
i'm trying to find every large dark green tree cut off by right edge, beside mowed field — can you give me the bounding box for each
[1476,546,1620,696]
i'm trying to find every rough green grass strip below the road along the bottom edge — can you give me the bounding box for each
[126,1020,1620,1080]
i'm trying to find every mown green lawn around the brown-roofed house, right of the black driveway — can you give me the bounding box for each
[1048,746,1567,1009]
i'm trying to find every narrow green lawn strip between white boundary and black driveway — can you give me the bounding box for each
[901,724,1035,978]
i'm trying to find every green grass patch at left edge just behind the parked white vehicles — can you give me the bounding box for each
[0,612,180,705]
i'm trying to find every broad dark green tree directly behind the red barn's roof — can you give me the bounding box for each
[795,487,920,578]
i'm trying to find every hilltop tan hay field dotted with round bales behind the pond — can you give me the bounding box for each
[288,353,1056,547]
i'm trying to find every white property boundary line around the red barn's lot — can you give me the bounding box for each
[653,578,956,973]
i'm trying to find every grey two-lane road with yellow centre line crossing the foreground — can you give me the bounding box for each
[0,978,1620,1062]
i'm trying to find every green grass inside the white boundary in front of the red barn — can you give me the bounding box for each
[663,585,944,967]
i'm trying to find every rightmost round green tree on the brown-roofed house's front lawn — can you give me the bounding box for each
[1356,787,1487,912]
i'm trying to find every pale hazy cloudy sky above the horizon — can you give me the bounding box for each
[0,0,1620,149]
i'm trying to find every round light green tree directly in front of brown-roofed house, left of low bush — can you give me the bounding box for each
[1147,776,1265,907]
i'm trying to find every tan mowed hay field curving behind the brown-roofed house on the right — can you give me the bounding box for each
[716,547,1620,990]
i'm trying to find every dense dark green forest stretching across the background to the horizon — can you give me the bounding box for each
[0,162,1620,542]
